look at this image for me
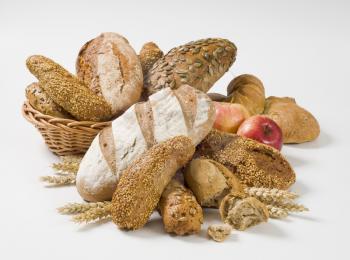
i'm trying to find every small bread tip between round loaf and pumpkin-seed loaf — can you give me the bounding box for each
[139,42,164,75]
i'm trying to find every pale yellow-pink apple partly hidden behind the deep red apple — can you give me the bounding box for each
[214,102,249,133]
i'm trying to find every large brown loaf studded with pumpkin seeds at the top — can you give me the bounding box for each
[144,38,237,96]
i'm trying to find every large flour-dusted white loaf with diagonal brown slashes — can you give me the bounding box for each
[76,85,215,201]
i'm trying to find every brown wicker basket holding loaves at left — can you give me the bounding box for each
[22,101,111,155]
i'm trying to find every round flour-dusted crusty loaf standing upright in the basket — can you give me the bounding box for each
[76,32,143,115]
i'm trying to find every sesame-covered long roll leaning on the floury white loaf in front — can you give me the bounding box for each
[111,136,195,229]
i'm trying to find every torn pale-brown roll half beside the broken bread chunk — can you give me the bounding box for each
[184,158,243,208]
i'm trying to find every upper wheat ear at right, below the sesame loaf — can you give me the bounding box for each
[244,187,298,204]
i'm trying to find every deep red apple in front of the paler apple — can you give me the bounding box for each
[237,115,283,150]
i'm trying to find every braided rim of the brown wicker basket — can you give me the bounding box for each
[22,100,112,130]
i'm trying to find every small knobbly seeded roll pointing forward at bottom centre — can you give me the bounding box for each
[158,179,203,236]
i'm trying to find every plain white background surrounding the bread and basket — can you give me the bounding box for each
[0,0,350,259]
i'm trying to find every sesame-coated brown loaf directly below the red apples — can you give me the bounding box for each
[196,130,295,190]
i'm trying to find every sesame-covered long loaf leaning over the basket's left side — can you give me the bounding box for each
[26,55,112,121]
